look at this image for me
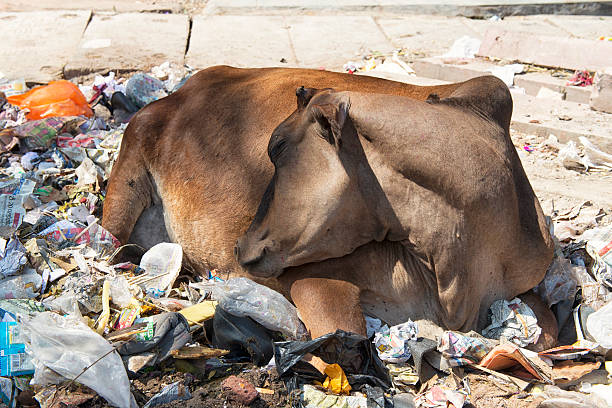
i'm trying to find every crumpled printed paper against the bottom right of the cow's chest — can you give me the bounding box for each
[482,298,542,347]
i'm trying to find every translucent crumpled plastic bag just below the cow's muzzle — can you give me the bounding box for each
[200,278,306,340]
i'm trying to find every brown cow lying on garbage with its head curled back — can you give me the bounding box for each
[103,67,556,350]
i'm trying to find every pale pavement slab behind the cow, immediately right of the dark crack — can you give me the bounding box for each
[186,16,297,68]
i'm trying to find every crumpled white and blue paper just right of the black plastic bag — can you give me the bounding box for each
[374,320,418,363]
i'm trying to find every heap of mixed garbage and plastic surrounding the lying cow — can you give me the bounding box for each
[0,64,612,408]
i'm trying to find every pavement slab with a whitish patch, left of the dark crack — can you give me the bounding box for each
[64,13,189,78]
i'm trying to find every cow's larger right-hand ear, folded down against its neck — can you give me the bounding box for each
[309,95,350,148]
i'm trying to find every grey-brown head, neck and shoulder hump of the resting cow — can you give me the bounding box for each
[237,83,554,338]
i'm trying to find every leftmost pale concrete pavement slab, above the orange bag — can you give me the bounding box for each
[0,10,91,83]
